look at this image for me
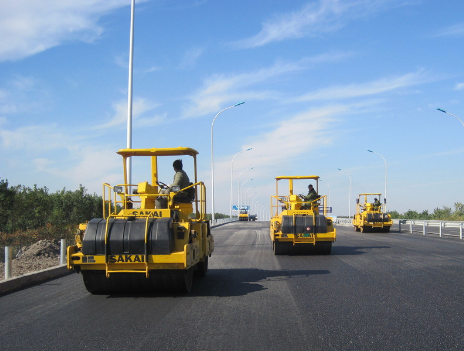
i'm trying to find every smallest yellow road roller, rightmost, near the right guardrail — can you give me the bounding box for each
[352,193,393,233]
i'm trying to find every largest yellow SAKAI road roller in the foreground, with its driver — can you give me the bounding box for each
[67,147,214,294]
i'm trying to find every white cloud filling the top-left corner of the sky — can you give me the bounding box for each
[0,0,146,61]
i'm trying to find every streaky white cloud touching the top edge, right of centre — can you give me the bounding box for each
[233,0,402,48]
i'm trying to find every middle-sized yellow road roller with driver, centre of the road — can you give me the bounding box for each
[270,175,337,255]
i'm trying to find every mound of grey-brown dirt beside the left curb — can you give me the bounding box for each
[0,240,60,280]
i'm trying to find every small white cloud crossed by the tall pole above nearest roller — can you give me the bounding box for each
[95,98,166,129]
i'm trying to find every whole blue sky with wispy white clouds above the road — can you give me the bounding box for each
[0,0,464,215]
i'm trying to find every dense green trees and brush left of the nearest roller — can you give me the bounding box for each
[0,180,103,260]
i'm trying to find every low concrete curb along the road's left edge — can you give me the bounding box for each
[0,265,73,296]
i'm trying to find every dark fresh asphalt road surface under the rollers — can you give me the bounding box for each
[0,222,464,351]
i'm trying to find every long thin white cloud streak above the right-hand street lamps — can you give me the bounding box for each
[293,71,430,101]
